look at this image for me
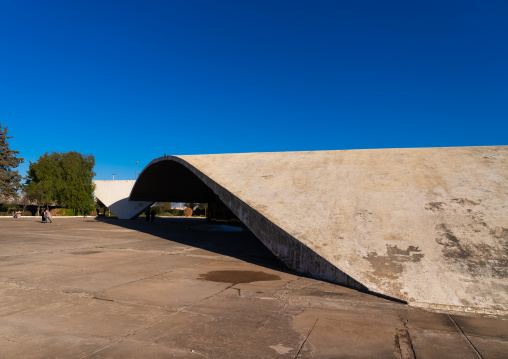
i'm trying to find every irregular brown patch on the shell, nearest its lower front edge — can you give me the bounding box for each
[364,244,424,279]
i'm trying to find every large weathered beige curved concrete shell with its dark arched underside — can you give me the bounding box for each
[130,146,508,314]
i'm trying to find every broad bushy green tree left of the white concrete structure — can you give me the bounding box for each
[25,151,95,214]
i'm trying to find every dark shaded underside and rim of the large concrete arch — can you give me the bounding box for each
[130,156,405,303]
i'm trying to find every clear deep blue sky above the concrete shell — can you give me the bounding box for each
[0,0,508,179]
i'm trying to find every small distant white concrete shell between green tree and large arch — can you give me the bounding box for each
[93,180,153,219]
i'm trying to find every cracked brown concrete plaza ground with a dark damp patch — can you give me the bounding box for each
[0,217,508,359]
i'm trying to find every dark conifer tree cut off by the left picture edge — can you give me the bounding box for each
[0,122,24,200]
